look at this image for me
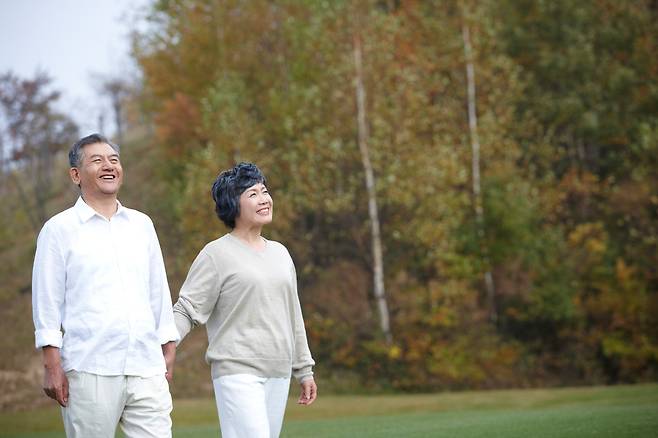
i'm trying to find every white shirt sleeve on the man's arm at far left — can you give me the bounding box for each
[32,222,66,348]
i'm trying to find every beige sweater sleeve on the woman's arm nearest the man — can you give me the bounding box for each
[174,250,219,343]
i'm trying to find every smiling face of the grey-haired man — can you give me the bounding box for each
[70,143,123,197]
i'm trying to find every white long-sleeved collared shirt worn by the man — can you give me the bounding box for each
[32,198,179,377]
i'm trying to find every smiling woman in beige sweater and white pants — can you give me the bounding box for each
[174,163,317,438]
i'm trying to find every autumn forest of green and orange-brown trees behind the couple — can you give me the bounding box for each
[0,0,658,408]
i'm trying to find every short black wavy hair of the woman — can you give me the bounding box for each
[212,163,267,228]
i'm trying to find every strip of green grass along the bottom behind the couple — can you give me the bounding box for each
[0,384,658,438]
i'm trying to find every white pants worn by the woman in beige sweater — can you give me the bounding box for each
[212,374,290,438]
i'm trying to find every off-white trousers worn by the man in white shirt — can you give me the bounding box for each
[62,371,172,438]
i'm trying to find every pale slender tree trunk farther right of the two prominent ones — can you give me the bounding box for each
[462,21,498,321]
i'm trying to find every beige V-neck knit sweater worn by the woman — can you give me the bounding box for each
[169,234,315,382]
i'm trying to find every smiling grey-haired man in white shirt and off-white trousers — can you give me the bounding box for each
[32,134,179,438]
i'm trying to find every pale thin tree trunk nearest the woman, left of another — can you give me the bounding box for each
[354,36,392,343]
